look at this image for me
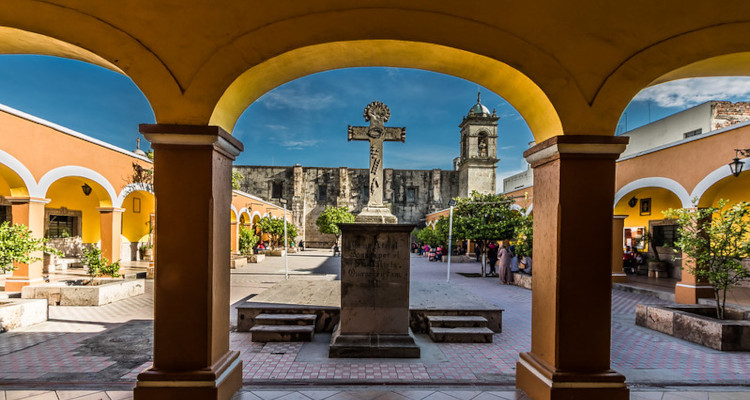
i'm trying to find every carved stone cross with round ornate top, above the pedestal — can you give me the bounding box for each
[349,101,406,208]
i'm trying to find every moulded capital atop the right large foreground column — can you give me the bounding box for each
[523,135,630,168]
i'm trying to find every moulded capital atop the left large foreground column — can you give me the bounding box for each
[138,124,245,160]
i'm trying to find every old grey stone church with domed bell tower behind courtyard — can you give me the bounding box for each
[234,98,499,247]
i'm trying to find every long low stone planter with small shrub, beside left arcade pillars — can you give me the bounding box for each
[21,278,146,306]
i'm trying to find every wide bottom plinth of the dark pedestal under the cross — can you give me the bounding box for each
[328,326,420,358]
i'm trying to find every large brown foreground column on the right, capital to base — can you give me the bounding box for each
[516,136,629,400]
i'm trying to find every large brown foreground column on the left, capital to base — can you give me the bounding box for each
[135,124,243,400]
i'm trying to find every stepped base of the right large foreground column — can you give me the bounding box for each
[516,353,630,400]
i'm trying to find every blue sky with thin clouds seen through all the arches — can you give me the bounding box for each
[0,55,750,185]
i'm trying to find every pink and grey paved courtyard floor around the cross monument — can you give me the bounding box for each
[0,250,750,400]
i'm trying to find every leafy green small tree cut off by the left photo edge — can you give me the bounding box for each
[0,221,62,274]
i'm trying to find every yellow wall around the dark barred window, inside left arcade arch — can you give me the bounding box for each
[47,177,101,243]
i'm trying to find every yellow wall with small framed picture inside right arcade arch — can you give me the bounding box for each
[614,188,682,250]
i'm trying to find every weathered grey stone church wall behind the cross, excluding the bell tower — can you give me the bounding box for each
[234,165,459,247]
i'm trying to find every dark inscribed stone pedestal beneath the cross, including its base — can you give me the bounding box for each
[329,223,420,358]
